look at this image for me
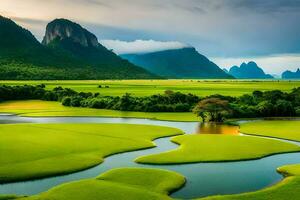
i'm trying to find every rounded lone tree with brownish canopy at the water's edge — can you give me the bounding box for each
[193,98,230,122]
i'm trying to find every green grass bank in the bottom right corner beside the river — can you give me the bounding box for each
[201,164,300,200]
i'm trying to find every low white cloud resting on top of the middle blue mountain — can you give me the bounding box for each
[100,40,189,54]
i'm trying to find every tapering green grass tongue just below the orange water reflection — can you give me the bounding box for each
[136,134,300,164]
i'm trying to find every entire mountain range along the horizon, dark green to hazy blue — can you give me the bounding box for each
[0,16,292,80]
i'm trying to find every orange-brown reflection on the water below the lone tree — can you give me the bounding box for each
[197,123,239,135]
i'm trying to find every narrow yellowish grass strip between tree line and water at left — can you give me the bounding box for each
[0,100,200,121]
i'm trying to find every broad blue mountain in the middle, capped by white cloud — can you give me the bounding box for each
[121,47,232,78]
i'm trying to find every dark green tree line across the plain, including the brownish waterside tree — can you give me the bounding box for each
[0,84,300,121]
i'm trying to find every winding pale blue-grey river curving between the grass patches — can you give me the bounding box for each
[0,115,300,198]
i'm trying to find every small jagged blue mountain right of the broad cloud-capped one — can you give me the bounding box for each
[229,62,274,79]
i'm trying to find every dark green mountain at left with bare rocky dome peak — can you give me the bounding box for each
[0,16,158,79]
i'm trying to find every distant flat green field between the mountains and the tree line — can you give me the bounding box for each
[0,80,300,96]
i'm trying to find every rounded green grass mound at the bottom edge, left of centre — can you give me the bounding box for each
[22,168,185,200]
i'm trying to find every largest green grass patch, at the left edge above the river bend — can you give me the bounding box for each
[0,124,182,183]
